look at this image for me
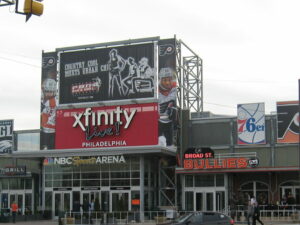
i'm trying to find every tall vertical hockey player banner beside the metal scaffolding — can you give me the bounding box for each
[158,39,178,146]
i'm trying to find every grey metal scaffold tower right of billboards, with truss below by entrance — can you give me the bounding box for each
[159,37,203,208]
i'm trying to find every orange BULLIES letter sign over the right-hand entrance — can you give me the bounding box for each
[183,157,258,169]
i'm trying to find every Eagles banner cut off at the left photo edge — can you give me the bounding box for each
[0,120,14,154]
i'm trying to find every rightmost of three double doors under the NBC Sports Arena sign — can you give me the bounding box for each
[109,190,131,212]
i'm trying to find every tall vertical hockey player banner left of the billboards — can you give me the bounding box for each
[40,52,58,149]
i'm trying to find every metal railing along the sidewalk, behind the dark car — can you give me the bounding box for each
[59,205,300,225]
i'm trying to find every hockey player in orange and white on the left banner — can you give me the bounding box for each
[41,78,57,149]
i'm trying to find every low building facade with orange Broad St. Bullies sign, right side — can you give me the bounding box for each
[176,113,300,213]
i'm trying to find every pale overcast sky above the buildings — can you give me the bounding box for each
[0,0,300,130]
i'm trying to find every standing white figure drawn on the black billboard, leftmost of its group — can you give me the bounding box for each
[108,49,126,97]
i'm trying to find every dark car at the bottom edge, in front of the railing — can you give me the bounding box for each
[171,212,234,225]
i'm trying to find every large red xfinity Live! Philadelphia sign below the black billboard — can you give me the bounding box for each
[55,103,158,149]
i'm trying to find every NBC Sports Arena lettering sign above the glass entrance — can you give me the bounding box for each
[43,155,126,166]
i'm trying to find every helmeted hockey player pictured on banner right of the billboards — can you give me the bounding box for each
[158,67,177,146]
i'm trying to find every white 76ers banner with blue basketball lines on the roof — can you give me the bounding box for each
[237,103,266,145]
